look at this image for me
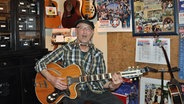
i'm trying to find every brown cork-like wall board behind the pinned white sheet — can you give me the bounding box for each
[107,32,182,80]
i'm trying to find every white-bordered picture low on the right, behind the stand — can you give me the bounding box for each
[139,77,171,104]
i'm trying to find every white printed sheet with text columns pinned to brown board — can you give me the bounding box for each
[135,38,170,64]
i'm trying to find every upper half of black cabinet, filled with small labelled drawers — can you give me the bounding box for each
[0,0,45,51]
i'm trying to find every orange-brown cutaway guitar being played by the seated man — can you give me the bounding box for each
[35,63,148,104]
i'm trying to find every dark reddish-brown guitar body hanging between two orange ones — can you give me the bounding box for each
[62,0,82,28]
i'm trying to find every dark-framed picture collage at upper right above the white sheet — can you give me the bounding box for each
[132,0,178,36]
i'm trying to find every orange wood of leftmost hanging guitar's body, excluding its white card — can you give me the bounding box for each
[45,0,61,28]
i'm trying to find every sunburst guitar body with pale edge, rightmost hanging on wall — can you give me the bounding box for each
[81,0,96,20]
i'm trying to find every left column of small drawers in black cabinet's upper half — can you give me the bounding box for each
[0,0,11,50]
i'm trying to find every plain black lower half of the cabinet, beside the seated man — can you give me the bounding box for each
[0,49,48,104]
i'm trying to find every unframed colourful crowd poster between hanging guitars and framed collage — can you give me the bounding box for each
[97,0,132,32]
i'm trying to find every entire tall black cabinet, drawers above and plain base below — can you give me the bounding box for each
[0,0,48,104]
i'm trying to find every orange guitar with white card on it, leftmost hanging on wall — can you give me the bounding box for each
[45,0,61,28]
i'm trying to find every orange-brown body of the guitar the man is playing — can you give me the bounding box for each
[35,63,81,104]
